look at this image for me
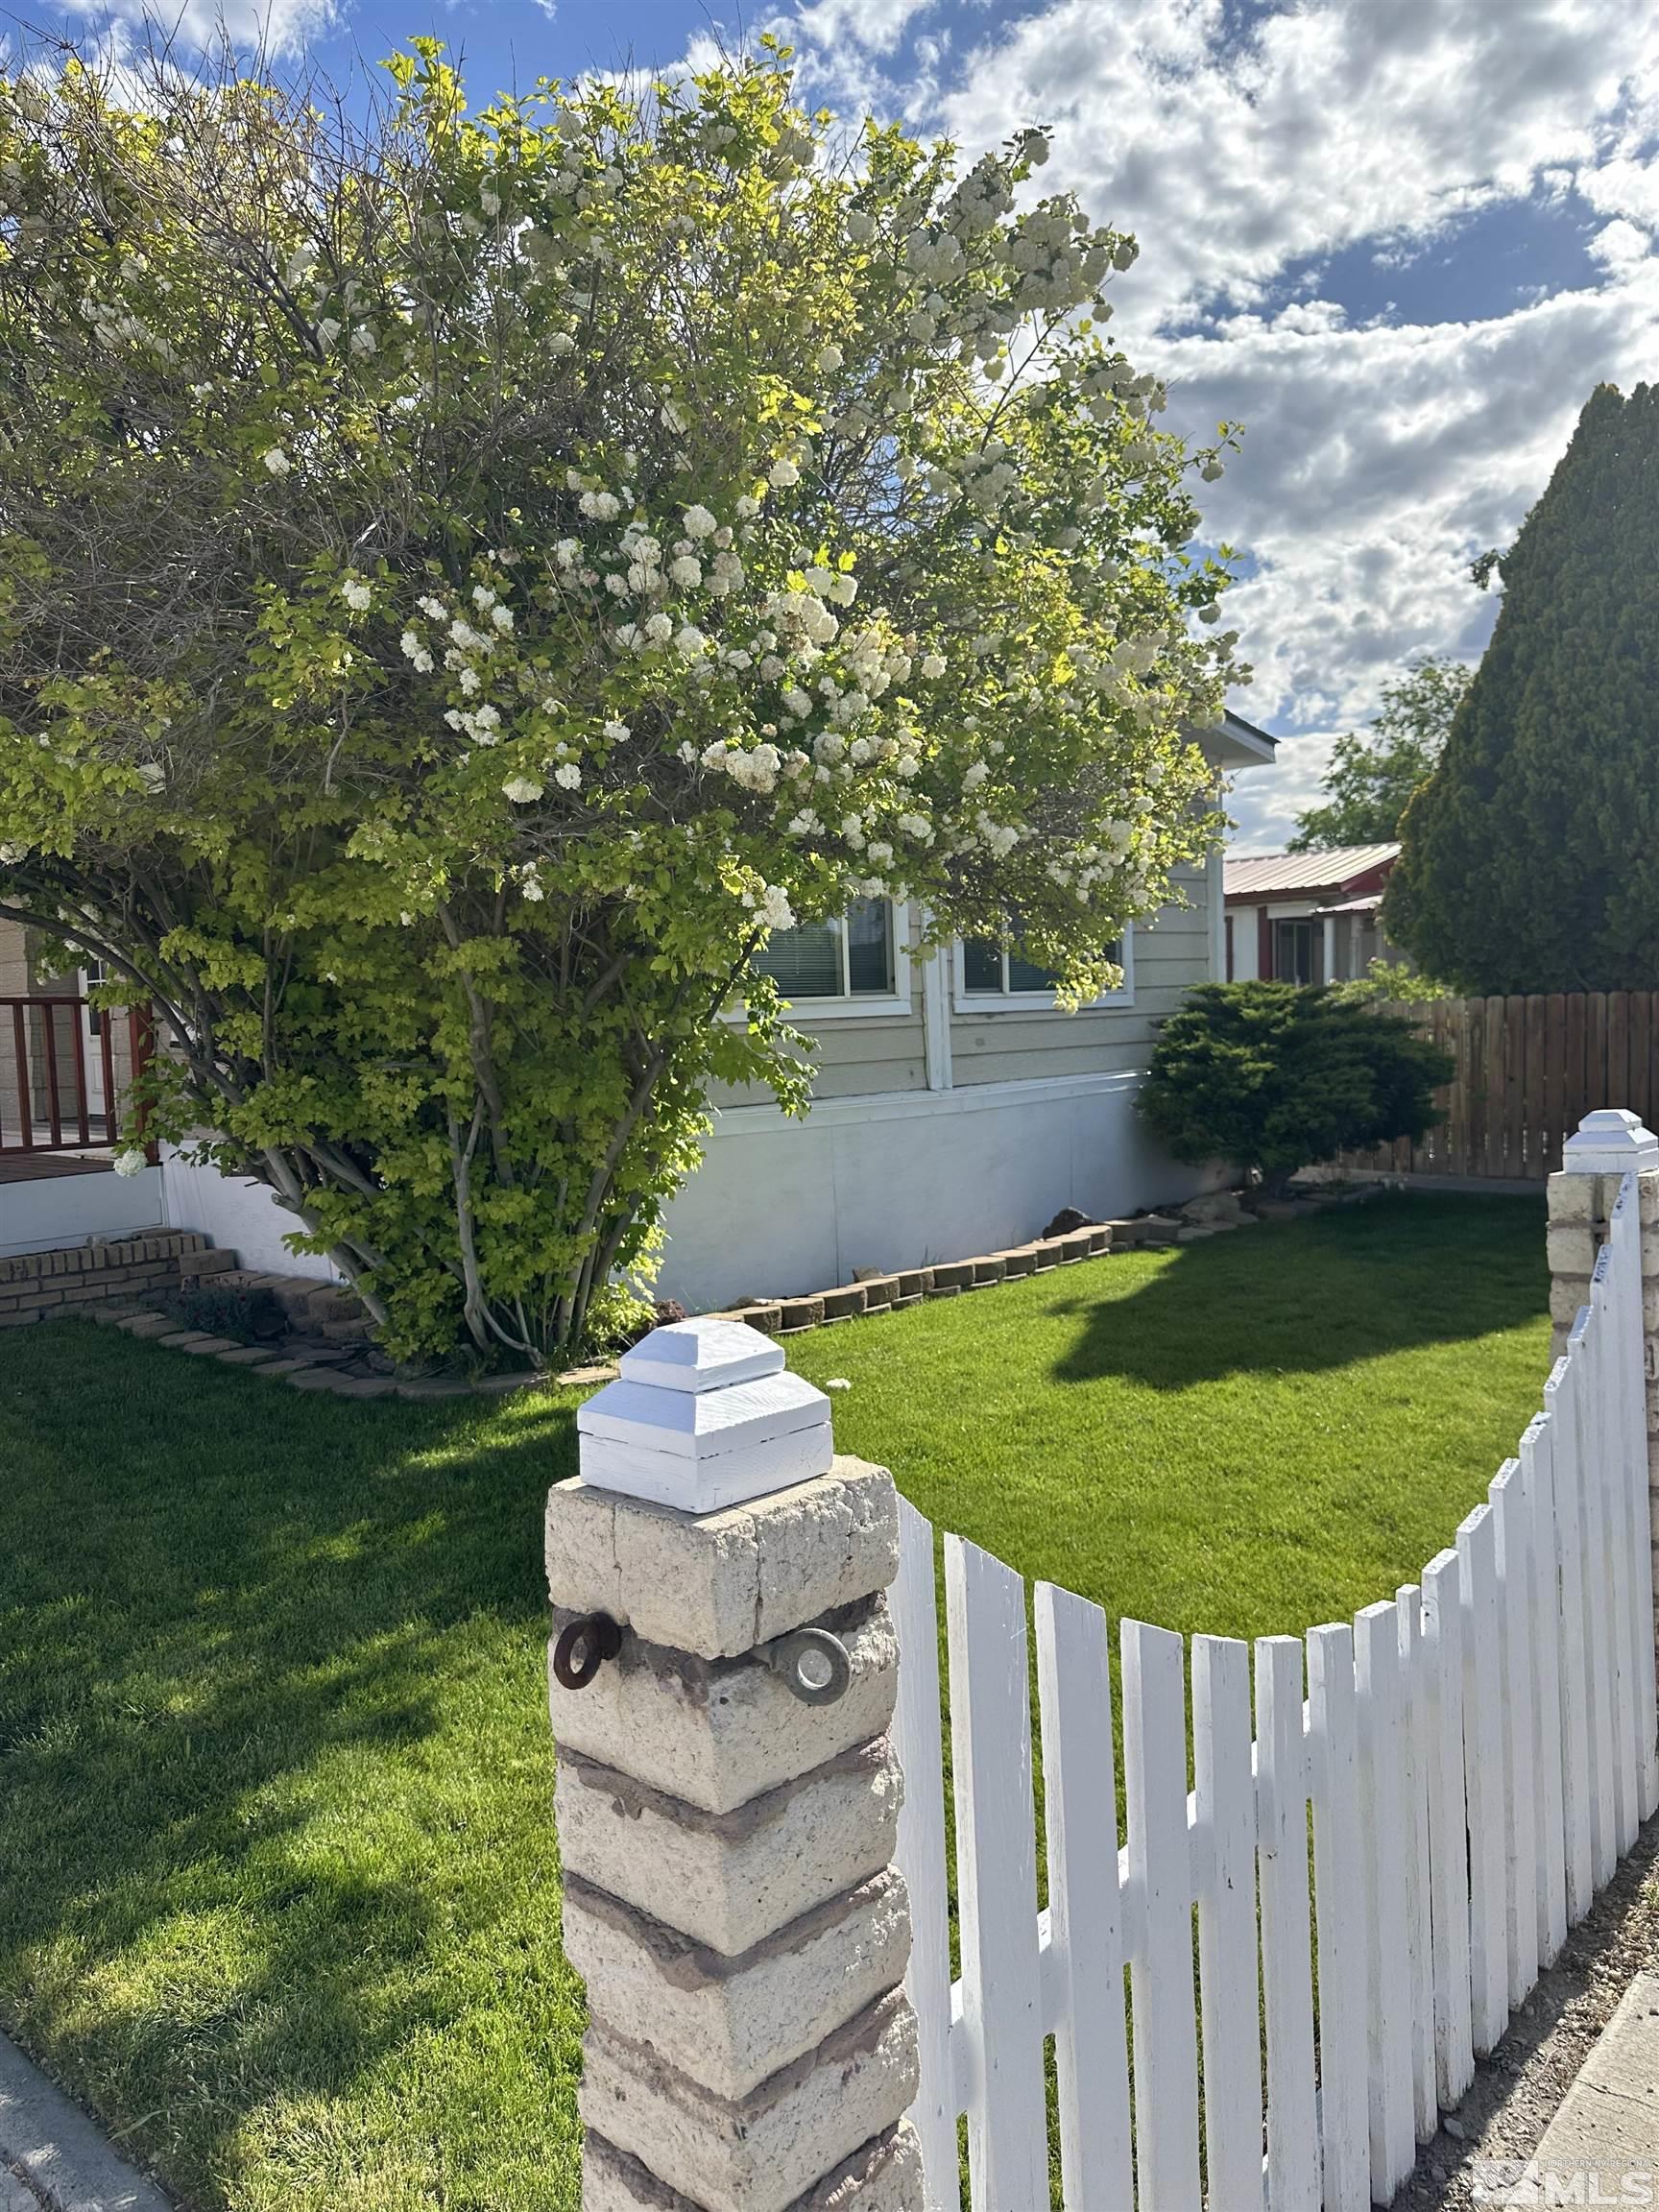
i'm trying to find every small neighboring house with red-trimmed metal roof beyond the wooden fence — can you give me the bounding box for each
[1225,845,1405,982]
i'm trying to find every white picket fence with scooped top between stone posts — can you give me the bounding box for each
[894,1177,1659,2212]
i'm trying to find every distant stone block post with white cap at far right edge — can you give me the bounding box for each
[1549,1106,1659,1654]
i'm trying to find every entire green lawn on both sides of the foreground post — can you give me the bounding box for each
[0,1199,1549,2212]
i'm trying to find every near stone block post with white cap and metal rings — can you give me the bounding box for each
[546,1318,923,2212]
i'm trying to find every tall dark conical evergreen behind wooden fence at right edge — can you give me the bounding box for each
[1382,385,1659,993]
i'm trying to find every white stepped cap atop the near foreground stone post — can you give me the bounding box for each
[575,1314,836,1513]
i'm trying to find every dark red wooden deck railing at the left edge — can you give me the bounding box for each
[0,991,155,1157]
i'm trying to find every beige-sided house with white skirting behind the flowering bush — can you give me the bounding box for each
[0,714,1274,1310]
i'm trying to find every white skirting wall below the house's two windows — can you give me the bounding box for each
[660,1075,1203,1311]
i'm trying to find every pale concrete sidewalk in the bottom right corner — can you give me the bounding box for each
[1520,1973,1659,2205]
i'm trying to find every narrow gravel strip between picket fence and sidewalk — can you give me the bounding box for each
[1394,1814,1659,2212]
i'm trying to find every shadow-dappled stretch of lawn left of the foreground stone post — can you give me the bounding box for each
[0,1325,580,2207]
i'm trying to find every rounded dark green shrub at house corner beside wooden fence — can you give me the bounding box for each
[1142,982,1451,1190]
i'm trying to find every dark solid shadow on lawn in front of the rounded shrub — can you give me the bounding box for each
[1053,1192,1549,1391]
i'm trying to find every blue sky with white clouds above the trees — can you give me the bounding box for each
[32,0,1659,850]
